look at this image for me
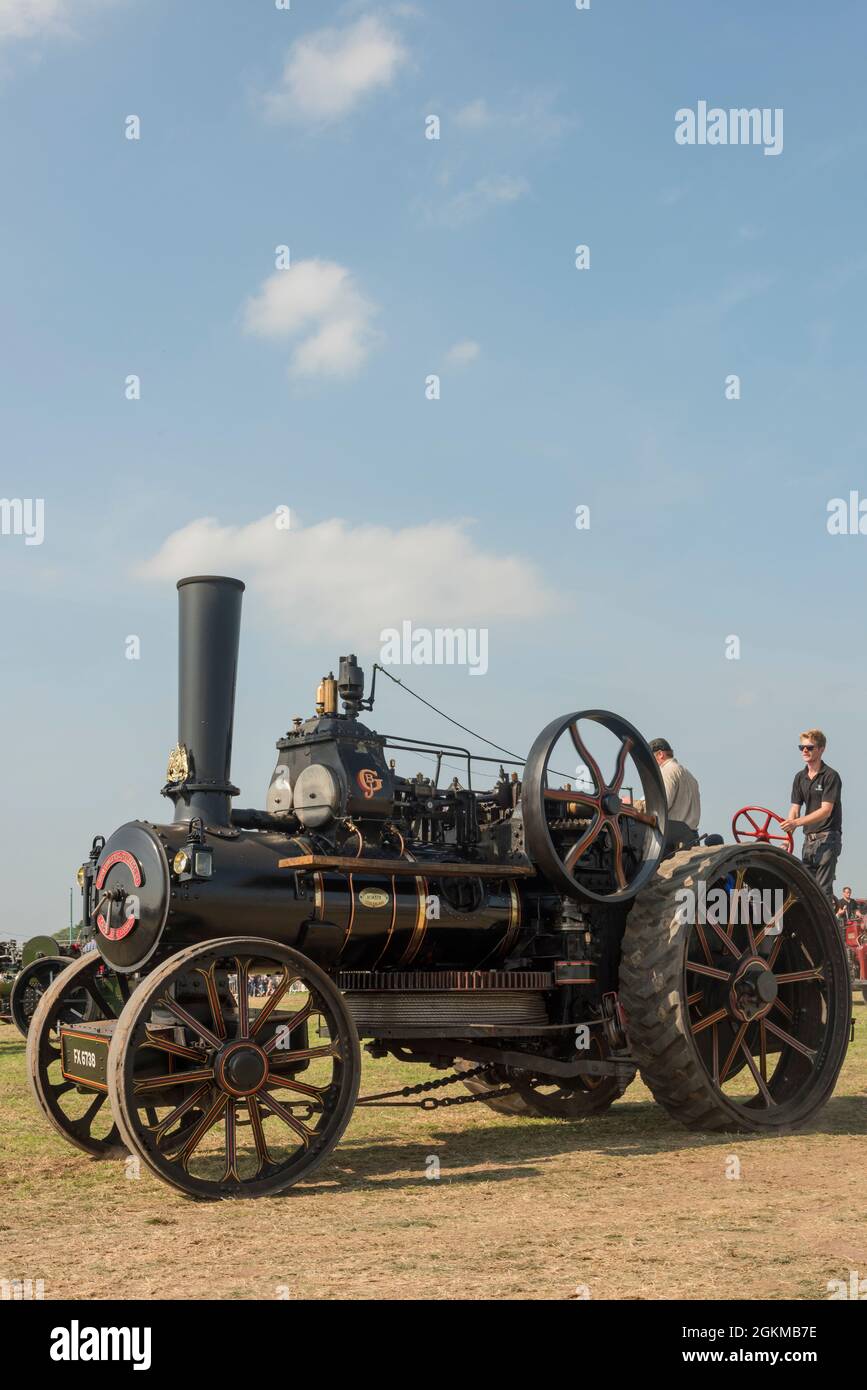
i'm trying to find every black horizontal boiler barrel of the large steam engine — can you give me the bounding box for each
[94,821,522,972]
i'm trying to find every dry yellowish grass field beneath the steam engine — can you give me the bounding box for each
[0,997,867,1300]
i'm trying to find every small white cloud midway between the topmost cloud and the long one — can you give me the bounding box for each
[243,260,377,377]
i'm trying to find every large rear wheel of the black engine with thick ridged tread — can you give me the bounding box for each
[620,845,852,1133]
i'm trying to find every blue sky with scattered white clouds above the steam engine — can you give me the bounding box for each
[0,0,867,935]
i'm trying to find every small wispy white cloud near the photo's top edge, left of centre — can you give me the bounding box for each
[265,15,408,121]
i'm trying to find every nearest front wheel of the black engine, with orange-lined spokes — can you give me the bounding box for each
[108,937,361,1198]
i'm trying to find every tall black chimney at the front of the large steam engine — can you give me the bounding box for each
[164,574,245,826]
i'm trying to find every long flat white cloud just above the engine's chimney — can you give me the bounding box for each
[138,514,560,642]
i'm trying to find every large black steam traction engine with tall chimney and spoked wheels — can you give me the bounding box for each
[28,577,850,1197]
